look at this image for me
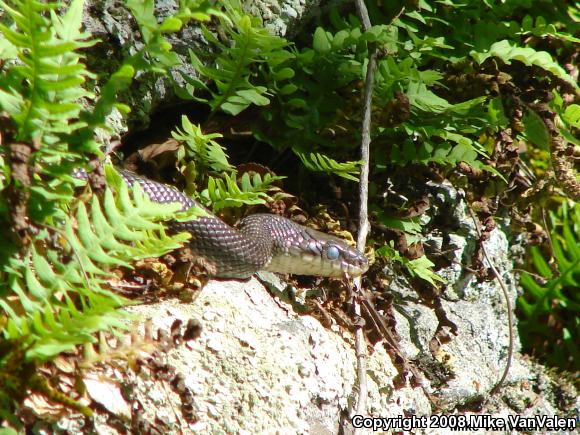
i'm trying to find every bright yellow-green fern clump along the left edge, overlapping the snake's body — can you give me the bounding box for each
[0,0,211,415]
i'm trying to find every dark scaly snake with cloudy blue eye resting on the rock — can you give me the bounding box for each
[75,169,369,279]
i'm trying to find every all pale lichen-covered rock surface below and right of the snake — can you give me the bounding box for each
[53,206,576,434]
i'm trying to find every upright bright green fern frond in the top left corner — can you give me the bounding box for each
[0,0,96,143]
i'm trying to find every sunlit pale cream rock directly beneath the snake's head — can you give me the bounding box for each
[122,278,429,433]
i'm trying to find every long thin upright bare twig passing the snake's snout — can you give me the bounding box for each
[353,0,377,426]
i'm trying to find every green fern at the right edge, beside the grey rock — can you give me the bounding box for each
[518,204,580,369]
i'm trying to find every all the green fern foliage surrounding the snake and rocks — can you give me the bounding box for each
[0,0,580,425]
